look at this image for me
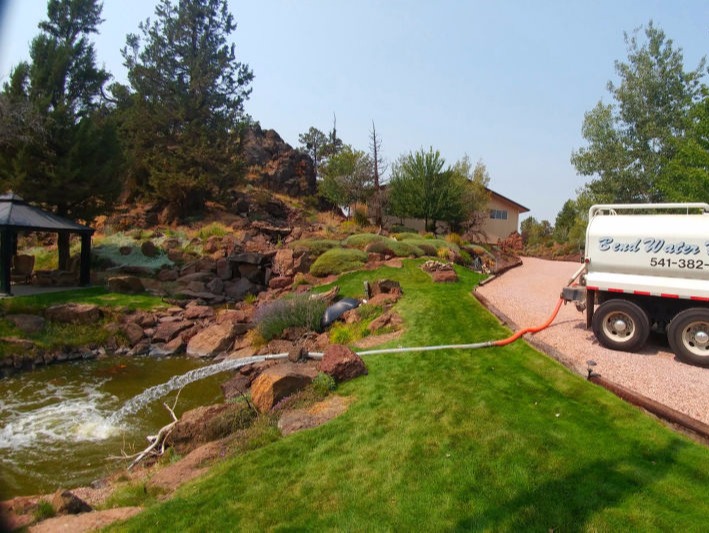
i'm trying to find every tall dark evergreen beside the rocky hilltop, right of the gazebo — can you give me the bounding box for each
[119,0,253,218]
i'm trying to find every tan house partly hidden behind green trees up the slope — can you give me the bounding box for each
[368,187,529,243]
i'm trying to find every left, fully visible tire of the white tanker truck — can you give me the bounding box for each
[592,299,650,352]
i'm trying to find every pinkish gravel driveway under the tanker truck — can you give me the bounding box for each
[476,257,709,424]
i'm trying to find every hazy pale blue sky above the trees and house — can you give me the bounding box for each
[0,0,709,224]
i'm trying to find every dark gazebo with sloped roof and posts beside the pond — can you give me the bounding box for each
[0,192,94,294]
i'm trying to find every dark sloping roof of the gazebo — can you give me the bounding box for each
[0,192,94,234]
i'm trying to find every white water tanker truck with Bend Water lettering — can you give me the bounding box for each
[564,203,709,367]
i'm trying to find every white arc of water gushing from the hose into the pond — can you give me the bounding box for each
[109,353,288,425]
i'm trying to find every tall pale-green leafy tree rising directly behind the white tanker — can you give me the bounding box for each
[571,21,705,202]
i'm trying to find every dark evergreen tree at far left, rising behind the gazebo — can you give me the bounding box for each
[0,0,120,268]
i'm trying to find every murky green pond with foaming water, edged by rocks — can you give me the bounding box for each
[0,357,226,500]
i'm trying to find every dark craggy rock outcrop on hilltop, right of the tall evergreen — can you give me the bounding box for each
[242,125,317,197]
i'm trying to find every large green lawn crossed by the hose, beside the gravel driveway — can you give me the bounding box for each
[109,261,709,532]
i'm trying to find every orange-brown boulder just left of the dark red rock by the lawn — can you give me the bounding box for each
[251,363,317,413]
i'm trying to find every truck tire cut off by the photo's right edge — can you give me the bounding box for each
[667,307,709,367]
